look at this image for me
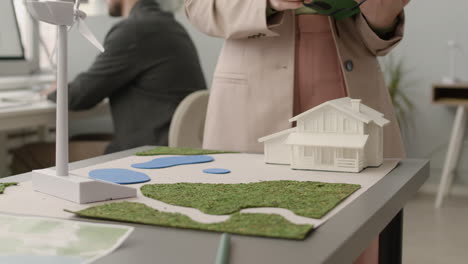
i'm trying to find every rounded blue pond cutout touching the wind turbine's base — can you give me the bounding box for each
[89,169,151,184]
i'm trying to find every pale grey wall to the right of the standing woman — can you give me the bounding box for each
[394,0,468,184]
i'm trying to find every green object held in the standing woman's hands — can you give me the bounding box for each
[304,0,367,20]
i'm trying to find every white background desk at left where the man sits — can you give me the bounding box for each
[0,89,110,177]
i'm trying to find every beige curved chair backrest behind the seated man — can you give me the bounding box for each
[169,90,209,148]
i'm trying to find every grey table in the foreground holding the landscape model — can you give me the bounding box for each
[0,147,429,264]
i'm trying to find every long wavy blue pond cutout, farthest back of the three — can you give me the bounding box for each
[132,155,214,169]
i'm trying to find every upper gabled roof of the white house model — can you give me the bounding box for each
[289,97,390,127]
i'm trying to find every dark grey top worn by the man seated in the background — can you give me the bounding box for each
[49,0,206,153]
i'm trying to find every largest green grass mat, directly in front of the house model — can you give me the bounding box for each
[141,181,361,219]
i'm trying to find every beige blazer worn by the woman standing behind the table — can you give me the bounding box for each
[185,0,405,158]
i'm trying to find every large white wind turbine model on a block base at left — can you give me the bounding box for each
[26,0,137,204]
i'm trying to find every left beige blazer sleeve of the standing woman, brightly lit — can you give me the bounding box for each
[185,0,278,39]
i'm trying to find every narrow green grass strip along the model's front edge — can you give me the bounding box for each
[68,202,313,239]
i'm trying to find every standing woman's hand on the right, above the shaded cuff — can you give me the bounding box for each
[361,0,410,28]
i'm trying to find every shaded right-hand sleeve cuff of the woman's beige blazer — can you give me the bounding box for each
[356,12,405,56]
